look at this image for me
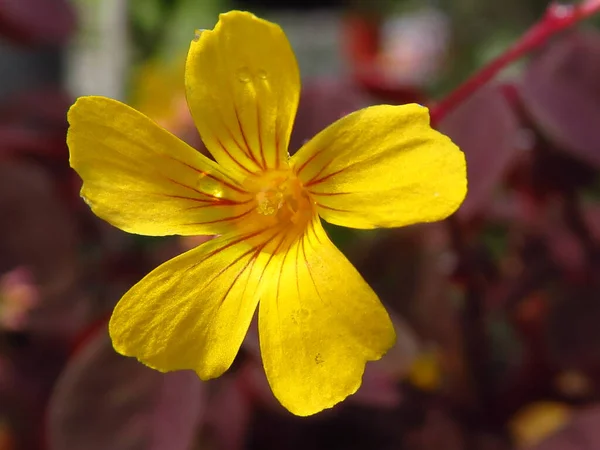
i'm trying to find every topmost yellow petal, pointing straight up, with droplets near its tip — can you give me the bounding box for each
[185,11,300,175]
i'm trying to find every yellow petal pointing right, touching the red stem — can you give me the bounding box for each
[291,104,467,228]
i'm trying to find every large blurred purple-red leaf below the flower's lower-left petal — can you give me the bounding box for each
[48,328,206,450]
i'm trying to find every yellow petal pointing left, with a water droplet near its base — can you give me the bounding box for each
[67,97,251,236]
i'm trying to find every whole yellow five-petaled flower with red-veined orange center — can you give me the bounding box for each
[67,11,466,415]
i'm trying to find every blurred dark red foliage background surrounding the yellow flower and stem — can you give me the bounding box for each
[0,0,600,450]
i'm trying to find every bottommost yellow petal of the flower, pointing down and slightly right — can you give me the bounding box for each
[259,218,395,416]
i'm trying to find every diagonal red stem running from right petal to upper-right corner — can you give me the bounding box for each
[430,0,600,124]
